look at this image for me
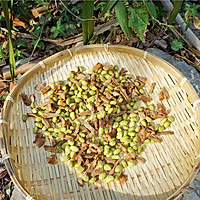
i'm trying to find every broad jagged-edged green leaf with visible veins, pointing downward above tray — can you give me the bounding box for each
[129,5,149,42]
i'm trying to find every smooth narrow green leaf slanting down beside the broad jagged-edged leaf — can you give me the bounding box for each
[114,0,133,37]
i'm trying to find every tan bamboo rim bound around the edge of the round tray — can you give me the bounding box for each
[0,44,200,199]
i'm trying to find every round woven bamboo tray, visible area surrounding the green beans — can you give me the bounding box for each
[0,45,200,200]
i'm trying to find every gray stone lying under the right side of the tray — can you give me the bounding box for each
[147,48,200,200]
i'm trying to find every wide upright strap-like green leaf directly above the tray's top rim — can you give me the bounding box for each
[82,0,94,44]
